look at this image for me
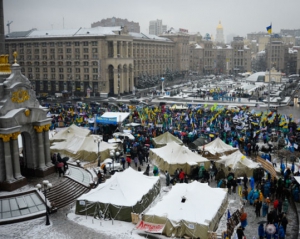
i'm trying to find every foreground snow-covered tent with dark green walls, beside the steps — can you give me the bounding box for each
[75,167,160,222]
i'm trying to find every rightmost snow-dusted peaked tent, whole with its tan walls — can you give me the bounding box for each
[216,150,260,177]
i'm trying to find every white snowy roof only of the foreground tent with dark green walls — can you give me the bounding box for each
[77,167,159,206]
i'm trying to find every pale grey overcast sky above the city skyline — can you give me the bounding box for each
[4,0,300,40]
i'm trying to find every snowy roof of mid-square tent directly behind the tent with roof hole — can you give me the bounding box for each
[150,142,209,165]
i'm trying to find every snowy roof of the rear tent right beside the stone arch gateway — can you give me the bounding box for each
[50,124,91,142]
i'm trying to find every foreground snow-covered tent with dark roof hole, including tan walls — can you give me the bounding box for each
[142,181,228,239]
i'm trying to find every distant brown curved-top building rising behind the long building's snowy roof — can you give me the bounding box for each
[91,17,140,33]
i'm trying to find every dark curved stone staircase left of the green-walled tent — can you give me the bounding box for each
[47,178,90,209]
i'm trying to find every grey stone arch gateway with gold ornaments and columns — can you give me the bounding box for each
[0,55,54,191]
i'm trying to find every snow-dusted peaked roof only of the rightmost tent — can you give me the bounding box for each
[217,150,260,170]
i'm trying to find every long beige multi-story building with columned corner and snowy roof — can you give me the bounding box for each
[6,26,179,95]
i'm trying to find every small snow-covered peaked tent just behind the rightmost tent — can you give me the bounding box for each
[199,137,237,159]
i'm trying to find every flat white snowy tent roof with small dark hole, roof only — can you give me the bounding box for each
[145,181,226,225]
